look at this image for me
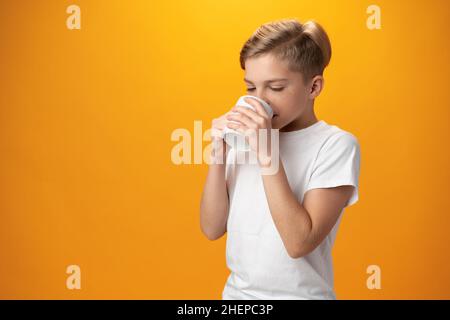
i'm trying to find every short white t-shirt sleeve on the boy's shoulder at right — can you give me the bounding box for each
[305,132,360,206]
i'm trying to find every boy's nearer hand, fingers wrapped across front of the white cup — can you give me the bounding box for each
[226,98,272,167]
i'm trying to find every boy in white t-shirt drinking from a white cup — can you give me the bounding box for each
[200,20,360,299]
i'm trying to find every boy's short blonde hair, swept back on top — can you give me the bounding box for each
[240,19,331,81]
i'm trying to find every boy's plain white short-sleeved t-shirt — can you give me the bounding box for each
[222,120,360,299]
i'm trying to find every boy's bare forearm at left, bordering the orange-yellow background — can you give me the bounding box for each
[200,142,229,240]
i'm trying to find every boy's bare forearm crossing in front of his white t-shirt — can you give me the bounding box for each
[262,159,312,257]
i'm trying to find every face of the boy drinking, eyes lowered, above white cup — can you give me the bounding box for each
[244,53,312,129]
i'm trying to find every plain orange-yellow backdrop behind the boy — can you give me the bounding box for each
[0,0,450,299]
